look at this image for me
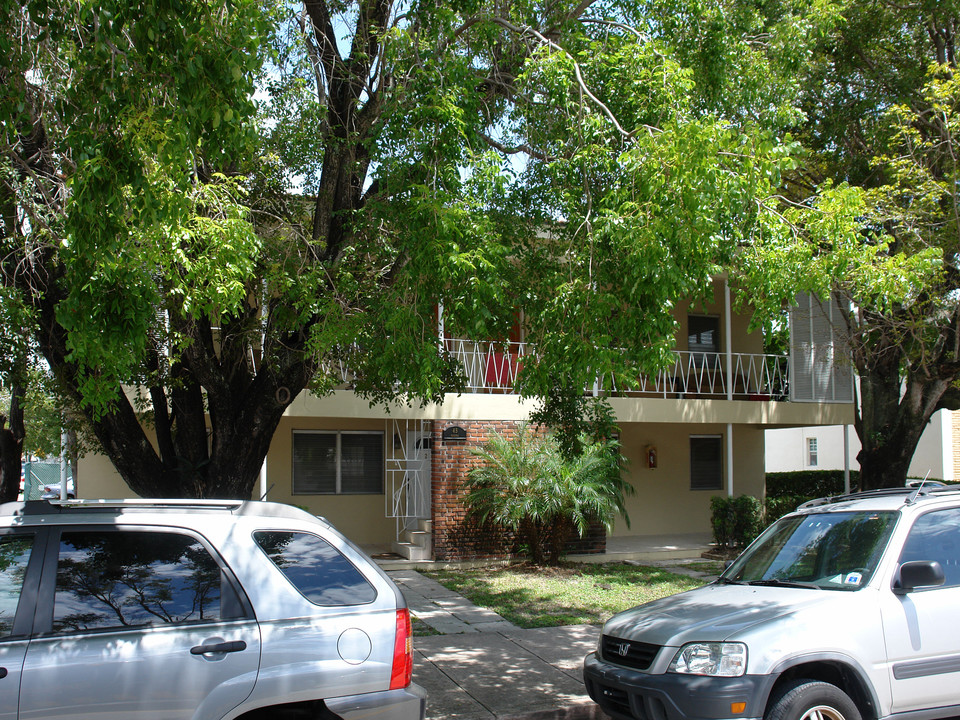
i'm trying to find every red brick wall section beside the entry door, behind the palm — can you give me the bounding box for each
[431,420,606,561]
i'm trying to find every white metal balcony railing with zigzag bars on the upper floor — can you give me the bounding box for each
[444,339,790,400]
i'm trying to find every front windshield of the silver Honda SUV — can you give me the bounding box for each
[719,512,898,590]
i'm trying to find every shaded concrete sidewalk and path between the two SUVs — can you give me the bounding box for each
[388,563,720,720]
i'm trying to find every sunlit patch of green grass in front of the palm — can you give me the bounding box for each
[424,564,705,628]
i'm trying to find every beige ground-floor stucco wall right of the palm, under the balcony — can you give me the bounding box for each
[612,423,764,536]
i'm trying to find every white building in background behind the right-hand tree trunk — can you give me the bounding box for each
[764,410,960,480]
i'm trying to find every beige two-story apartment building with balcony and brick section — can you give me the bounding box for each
[79,278,853,560]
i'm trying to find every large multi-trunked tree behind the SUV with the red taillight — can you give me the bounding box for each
[0,0,810,497]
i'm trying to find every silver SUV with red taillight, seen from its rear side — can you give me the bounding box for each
[0,501,425,720]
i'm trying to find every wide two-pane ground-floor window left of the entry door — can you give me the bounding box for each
[293,430,384,495]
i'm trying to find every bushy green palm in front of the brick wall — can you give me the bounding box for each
[463,424,633,564]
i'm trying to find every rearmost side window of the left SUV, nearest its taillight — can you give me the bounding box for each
[254,530,377,605]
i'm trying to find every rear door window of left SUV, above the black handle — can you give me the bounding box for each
[53,531,221,632]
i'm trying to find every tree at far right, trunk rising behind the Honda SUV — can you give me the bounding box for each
[742,0,960,489]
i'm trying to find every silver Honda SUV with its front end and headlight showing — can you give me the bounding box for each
[584,488,960,720]
